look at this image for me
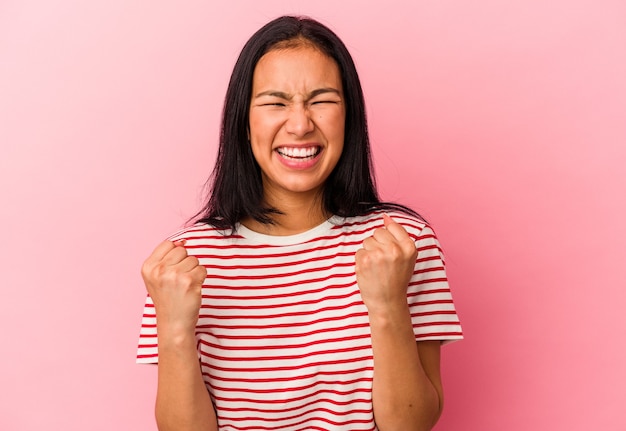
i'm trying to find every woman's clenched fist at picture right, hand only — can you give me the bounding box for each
[355,214,417,313]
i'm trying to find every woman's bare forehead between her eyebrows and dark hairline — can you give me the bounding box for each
[253,45,341,91]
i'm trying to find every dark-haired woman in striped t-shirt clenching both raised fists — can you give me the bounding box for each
[138,17,461,431]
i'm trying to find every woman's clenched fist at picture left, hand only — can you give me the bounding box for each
[141,241,207,333]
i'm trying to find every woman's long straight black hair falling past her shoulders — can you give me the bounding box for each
[194,16,421,231]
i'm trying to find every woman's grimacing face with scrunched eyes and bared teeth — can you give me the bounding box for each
[250,46,346,204]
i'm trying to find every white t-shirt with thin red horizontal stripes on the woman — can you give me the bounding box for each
[137,212,462,431]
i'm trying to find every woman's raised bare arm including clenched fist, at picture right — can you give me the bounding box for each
[355,215,443,431]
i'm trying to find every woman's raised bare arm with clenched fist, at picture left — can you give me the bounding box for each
[141,241,217,431]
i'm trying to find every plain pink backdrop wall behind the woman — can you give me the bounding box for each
[0,0,626,431]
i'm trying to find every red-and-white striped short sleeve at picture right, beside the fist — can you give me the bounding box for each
[407,225,463,342]
